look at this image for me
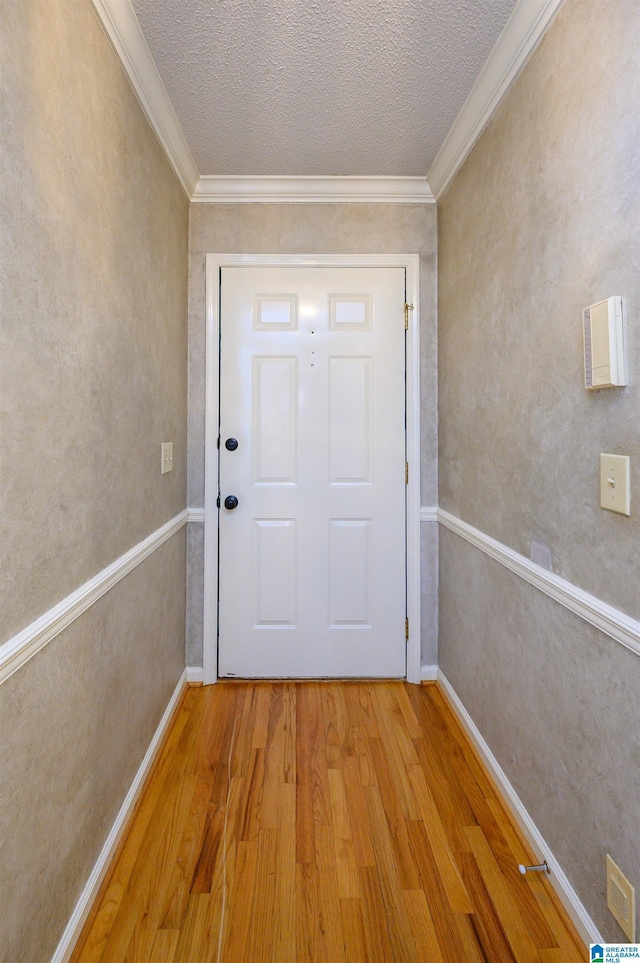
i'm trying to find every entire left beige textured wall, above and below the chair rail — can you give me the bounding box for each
[0,0,188,963]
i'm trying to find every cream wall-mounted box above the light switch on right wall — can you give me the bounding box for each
[582,297,627,389]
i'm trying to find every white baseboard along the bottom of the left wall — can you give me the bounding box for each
[51,669,187,963]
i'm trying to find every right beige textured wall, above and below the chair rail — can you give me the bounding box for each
[438,0,640,934]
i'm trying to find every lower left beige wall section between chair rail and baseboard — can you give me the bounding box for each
[0,529,186,963]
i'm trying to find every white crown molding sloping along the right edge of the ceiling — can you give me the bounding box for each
[427,0,563,199]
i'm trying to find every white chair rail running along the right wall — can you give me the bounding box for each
[438,508,640,655]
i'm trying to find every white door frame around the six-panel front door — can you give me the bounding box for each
[203,254,420,685]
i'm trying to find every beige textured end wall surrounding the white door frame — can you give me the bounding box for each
[187,204,438,665]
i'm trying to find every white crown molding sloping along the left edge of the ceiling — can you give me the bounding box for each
[91,0,198,199]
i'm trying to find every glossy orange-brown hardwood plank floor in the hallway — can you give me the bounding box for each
[72,682,586,963]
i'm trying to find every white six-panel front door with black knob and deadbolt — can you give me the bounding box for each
[218,267,406,678]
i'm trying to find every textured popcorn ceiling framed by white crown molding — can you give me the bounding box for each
[132,0,515,176]
